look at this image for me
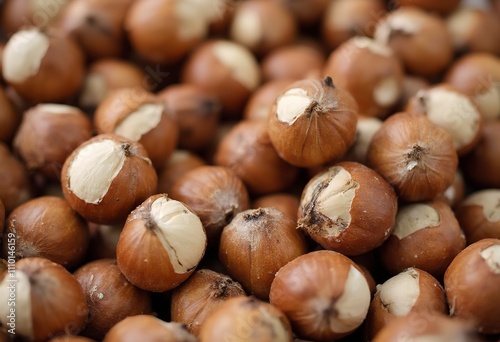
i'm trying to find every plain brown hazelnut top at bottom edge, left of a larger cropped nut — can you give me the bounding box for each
[103,315,196,342]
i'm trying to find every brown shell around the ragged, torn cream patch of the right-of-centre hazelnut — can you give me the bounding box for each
[297,162,398,255]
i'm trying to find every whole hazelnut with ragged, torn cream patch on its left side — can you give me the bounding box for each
[297,162,398,255]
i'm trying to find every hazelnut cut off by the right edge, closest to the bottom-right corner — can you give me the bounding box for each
[444,239,500,334]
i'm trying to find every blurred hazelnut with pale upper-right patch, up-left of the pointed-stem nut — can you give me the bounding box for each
[183,39,260,118]
